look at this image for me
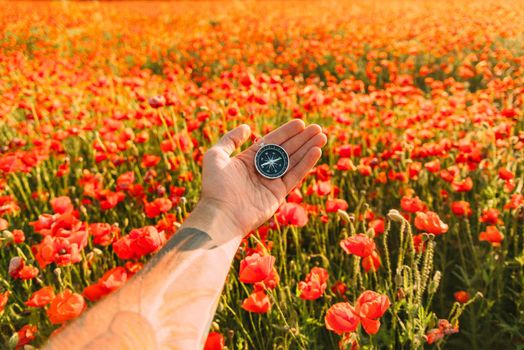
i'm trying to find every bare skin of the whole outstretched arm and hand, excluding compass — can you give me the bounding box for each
[45,120,327,350]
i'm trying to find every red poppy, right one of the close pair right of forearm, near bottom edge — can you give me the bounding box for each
[355,290,390,334]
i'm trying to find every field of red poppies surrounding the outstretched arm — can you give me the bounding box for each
[0,0,524,350]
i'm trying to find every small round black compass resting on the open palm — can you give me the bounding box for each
[255,145,289,179]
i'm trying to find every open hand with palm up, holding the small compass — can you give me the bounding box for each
[199,119,327,235]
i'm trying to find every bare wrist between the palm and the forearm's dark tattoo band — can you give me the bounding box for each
[182,198,246,242]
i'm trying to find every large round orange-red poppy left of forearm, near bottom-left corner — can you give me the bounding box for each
[47,289,86,324]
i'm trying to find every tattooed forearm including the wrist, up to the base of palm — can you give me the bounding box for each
[44,202,244,349]
